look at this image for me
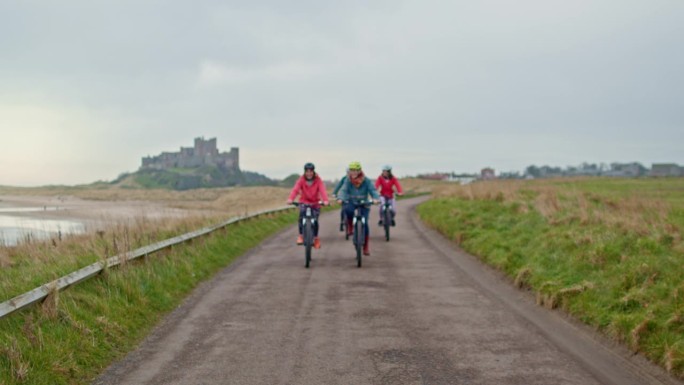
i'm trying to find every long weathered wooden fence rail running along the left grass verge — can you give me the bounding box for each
[0,206,292,319]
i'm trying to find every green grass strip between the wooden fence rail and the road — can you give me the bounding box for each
[0,211,296,385]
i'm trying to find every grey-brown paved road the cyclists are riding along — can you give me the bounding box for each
[95,199,679,385]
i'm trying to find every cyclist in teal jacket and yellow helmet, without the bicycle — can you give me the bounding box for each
[337,161,380,255]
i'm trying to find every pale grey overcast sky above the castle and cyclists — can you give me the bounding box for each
[0,0,684,186]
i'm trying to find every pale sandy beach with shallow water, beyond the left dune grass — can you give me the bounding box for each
[0,187,287,245]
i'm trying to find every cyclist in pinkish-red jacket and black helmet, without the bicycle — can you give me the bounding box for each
[287,162,329,249]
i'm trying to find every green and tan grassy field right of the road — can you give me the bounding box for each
[418,178,684,378]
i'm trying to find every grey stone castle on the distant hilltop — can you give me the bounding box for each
[140,137,240,171]
